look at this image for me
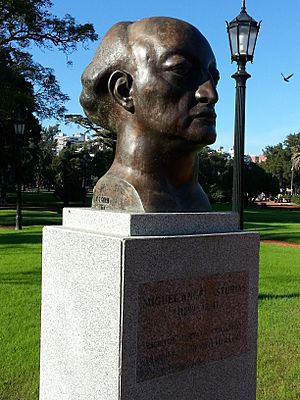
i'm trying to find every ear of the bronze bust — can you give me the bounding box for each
[108,70,133,112]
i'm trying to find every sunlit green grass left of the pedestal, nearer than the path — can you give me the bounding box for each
[0,227,41,400]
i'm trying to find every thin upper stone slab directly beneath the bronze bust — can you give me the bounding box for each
[63,208,239,236]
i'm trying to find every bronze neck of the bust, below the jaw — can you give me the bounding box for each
[110,129,202,189]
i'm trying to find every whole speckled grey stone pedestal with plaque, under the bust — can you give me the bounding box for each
[40,209,259,400]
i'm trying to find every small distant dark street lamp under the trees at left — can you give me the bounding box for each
[13,113,25,230]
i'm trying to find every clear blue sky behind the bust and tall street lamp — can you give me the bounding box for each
[31,0,300,155]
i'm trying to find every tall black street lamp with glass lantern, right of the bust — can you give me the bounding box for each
[226,0,260,229]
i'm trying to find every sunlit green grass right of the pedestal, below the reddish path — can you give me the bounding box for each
[257,243,300,400]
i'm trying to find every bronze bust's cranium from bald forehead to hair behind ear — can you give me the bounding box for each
[80,17,217,137]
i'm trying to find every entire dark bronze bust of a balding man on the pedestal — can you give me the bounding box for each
[80,17,219,212]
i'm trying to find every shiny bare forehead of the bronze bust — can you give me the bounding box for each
[128,17,214,63]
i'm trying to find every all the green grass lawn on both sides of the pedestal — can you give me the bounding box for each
[0,205,300,400]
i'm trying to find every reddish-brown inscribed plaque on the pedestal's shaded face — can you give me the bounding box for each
[137,271,248,382]
